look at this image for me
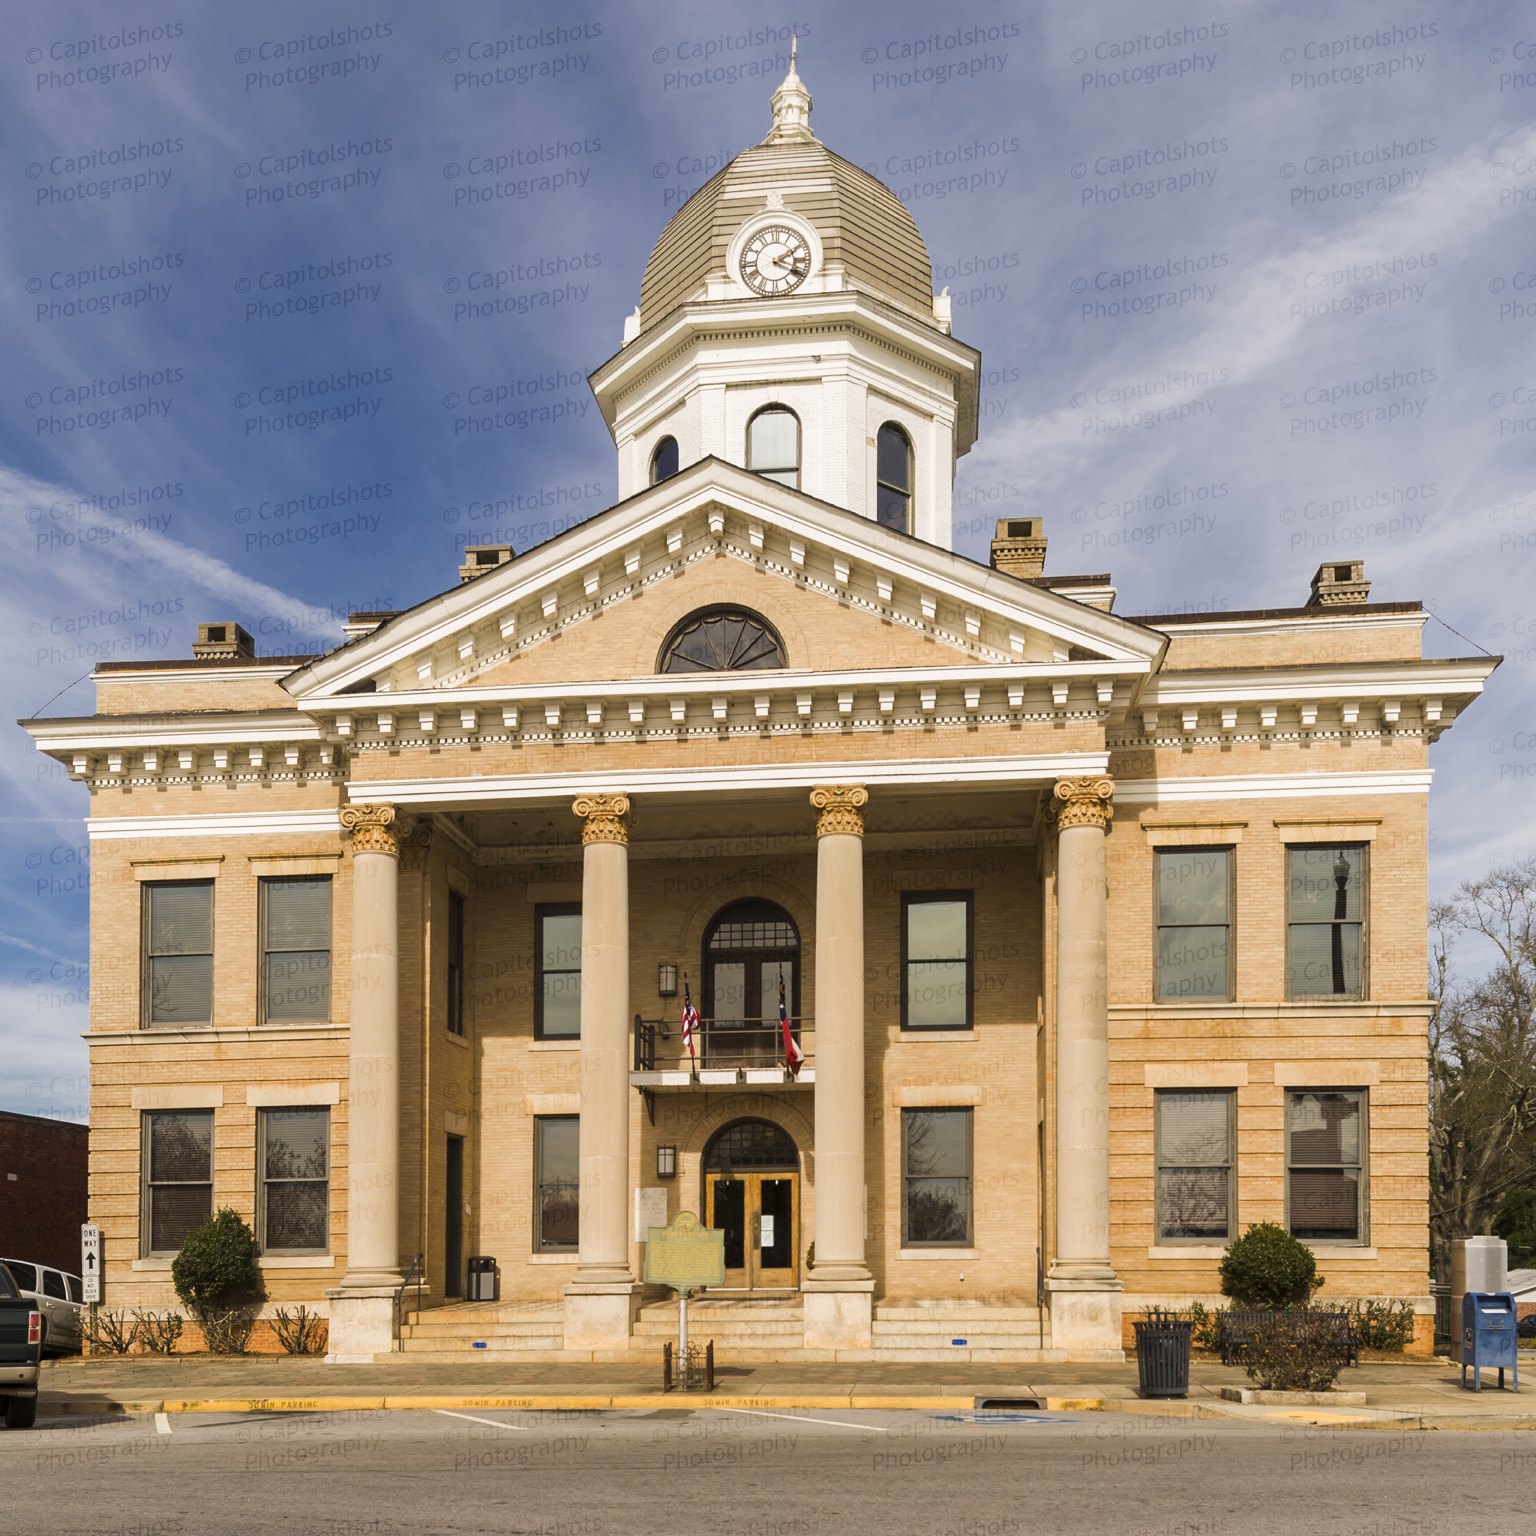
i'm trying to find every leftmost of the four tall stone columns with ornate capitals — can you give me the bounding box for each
[327,805,407,1361]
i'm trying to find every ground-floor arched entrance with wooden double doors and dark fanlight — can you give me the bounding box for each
[703,1120,800,1290]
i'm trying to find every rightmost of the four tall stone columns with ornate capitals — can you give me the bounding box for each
[1046,779,1123,1358]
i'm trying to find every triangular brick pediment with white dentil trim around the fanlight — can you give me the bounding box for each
[284,458,1164,708]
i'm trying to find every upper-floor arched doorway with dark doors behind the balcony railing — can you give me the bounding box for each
[702,900,800,1066]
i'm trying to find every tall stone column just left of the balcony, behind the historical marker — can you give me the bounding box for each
[565,794,639,1349]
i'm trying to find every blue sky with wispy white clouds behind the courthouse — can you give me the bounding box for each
[0,0,1536,1118]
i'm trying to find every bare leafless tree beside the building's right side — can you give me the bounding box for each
[1430,859,1536,1281]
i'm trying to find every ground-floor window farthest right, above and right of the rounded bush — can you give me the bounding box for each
[1286,1089,1366,1243]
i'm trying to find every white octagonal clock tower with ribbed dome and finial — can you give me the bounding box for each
[591,60,982,548]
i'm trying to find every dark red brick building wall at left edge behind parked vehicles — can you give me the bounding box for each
[0,1109,86,1275]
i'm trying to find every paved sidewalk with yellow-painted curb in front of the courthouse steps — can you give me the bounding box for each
[27,1355,1536,1428]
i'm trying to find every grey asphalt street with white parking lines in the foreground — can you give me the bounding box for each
[0,1404,1536,1536]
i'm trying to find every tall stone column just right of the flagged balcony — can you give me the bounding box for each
[803,785,874,1349]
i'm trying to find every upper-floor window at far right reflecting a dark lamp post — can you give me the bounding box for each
[1286,843,1366,998]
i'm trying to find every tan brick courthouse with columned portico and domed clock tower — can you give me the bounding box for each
[26,69,1495,1366]
